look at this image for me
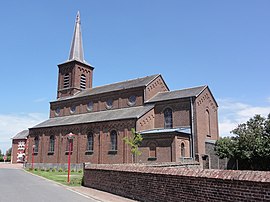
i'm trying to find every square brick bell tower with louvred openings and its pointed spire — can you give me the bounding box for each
[57,11,94,99]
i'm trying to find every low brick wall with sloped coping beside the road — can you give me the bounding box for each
[84,164,270,201]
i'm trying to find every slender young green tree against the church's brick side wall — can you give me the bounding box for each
[123,128,143,162]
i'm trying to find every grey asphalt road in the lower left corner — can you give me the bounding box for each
[0,168,95,202]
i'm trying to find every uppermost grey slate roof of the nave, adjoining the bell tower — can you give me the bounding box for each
[56,74,160,100]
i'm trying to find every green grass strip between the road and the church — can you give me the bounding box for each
[27,169,83,186]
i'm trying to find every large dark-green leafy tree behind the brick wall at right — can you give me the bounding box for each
[215,114,270,170]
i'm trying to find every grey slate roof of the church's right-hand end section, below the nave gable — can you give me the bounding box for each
[147,86,207,103]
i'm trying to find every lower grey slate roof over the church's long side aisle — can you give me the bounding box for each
[33,105,154,128]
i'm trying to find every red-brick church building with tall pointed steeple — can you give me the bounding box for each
[27,13,219,169]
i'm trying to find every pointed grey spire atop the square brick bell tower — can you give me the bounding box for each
[68,11,85,63]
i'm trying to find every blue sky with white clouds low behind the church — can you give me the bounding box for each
[0,0,270,152]
